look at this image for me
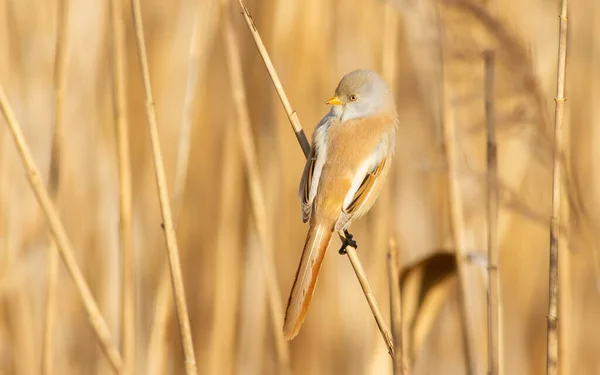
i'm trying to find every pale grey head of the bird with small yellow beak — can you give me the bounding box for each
[326,69,395,121]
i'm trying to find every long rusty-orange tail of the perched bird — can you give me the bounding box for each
[283,225,333,340]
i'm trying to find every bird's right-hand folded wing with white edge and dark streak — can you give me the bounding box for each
[335,158,388,230]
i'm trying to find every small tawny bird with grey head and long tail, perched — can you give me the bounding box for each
[283,69,398,340]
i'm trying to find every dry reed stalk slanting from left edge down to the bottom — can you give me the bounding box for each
[0,85,124,374]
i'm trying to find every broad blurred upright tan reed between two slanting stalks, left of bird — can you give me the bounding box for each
[208,121,243,375]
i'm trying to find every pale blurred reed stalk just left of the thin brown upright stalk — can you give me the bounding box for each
[441,51,477,375]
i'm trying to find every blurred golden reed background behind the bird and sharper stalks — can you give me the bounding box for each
[0,0,600,375]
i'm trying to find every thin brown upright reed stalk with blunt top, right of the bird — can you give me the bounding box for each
[484,51,502,375]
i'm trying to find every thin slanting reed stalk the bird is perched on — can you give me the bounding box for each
[238,0,394,354]
